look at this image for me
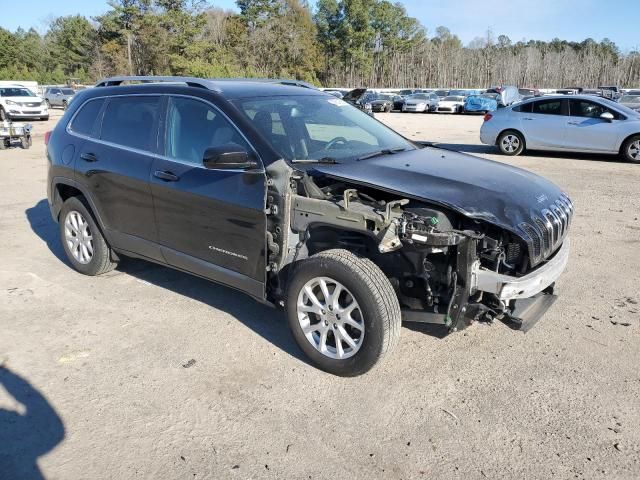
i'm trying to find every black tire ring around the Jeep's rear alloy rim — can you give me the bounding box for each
[58,197,111,275]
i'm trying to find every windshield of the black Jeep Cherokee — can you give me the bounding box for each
[234,95,415,162]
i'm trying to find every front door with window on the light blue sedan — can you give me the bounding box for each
[566,98,624,152]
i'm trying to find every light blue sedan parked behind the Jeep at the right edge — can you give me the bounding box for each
[480,95,640,164]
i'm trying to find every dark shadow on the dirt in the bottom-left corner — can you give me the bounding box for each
[0,365,65,480]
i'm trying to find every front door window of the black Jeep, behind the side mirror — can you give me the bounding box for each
[164,97,250,165]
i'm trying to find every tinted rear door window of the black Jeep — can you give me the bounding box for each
[100,96,160,150]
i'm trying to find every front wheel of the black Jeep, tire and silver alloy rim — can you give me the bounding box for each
[286,250,401,377]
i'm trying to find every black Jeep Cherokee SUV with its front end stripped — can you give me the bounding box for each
[47,77,573,375]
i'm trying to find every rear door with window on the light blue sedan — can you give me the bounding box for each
[520,98,568,149]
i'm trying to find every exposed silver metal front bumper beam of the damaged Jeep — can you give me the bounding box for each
[471,238,571,301]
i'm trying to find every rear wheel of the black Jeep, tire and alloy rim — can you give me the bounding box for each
[58,197,117,276]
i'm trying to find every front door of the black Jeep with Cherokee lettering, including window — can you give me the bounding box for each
[151,97,266,296]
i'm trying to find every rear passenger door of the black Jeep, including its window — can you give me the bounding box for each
[76,95,162,260]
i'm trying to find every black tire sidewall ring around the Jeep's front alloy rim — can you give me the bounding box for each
[286,257,384,376]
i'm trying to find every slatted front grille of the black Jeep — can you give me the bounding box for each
[519,194,573,266]
